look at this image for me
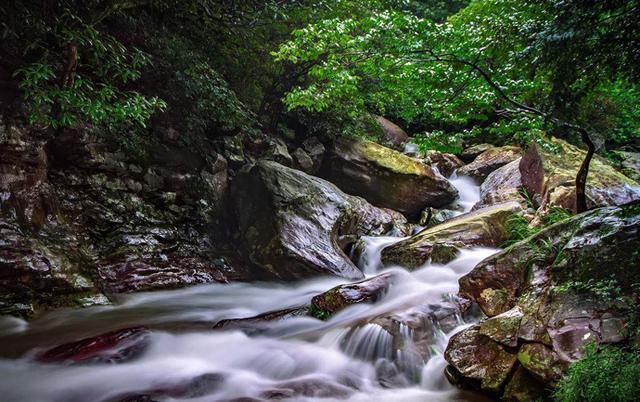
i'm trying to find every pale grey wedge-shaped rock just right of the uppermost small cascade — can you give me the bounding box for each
[474,158,526,209]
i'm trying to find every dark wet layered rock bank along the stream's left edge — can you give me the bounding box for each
[0,126,246,316]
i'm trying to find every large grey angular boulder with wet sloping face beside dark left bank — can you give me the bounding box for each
[232,161,406,280]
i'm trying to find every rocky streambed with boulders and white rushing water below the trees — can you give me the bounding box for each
[0,123,640,401]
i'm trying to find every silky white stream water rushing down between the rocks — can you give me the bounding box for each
[0,174,496,402]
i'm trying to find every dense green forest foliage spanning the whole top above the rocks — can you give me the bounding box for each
[0,0,640,152]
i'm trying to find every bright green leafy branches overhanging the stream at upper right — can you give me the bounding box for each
[277,0,640,149]
